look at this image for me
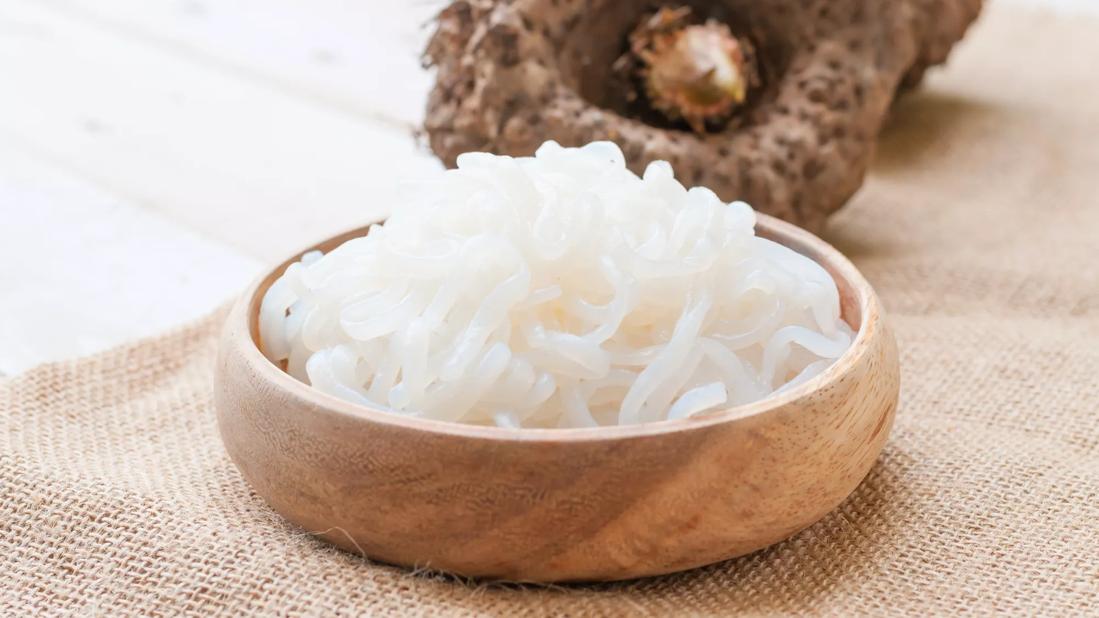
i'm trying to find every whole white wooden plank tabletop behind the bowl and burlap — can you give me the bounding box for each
[0,0,1099,374]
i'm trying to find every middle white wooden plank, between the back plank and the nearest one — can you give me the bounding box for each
[0,0,441,260]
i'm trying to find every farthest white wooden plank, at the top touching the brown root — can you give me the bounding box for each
[37,0,445,125]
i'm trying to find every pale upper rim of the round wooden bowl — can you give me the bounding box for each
[223,213,884,442]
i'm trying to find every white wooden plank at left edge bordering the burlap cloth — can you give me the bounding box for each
[0,145,259,374]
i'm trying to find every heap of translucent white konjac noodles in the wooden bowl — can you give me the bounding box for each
[259,142,853,428]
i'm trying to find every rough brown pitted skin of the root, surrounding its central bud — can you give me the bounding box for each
[425,0,981,231]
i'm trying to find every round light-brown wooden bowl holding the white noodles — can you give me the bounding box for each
[217,216,899,582]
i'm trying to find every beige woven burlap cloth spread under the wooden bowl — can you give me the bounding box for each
[0,4,1099,616]
